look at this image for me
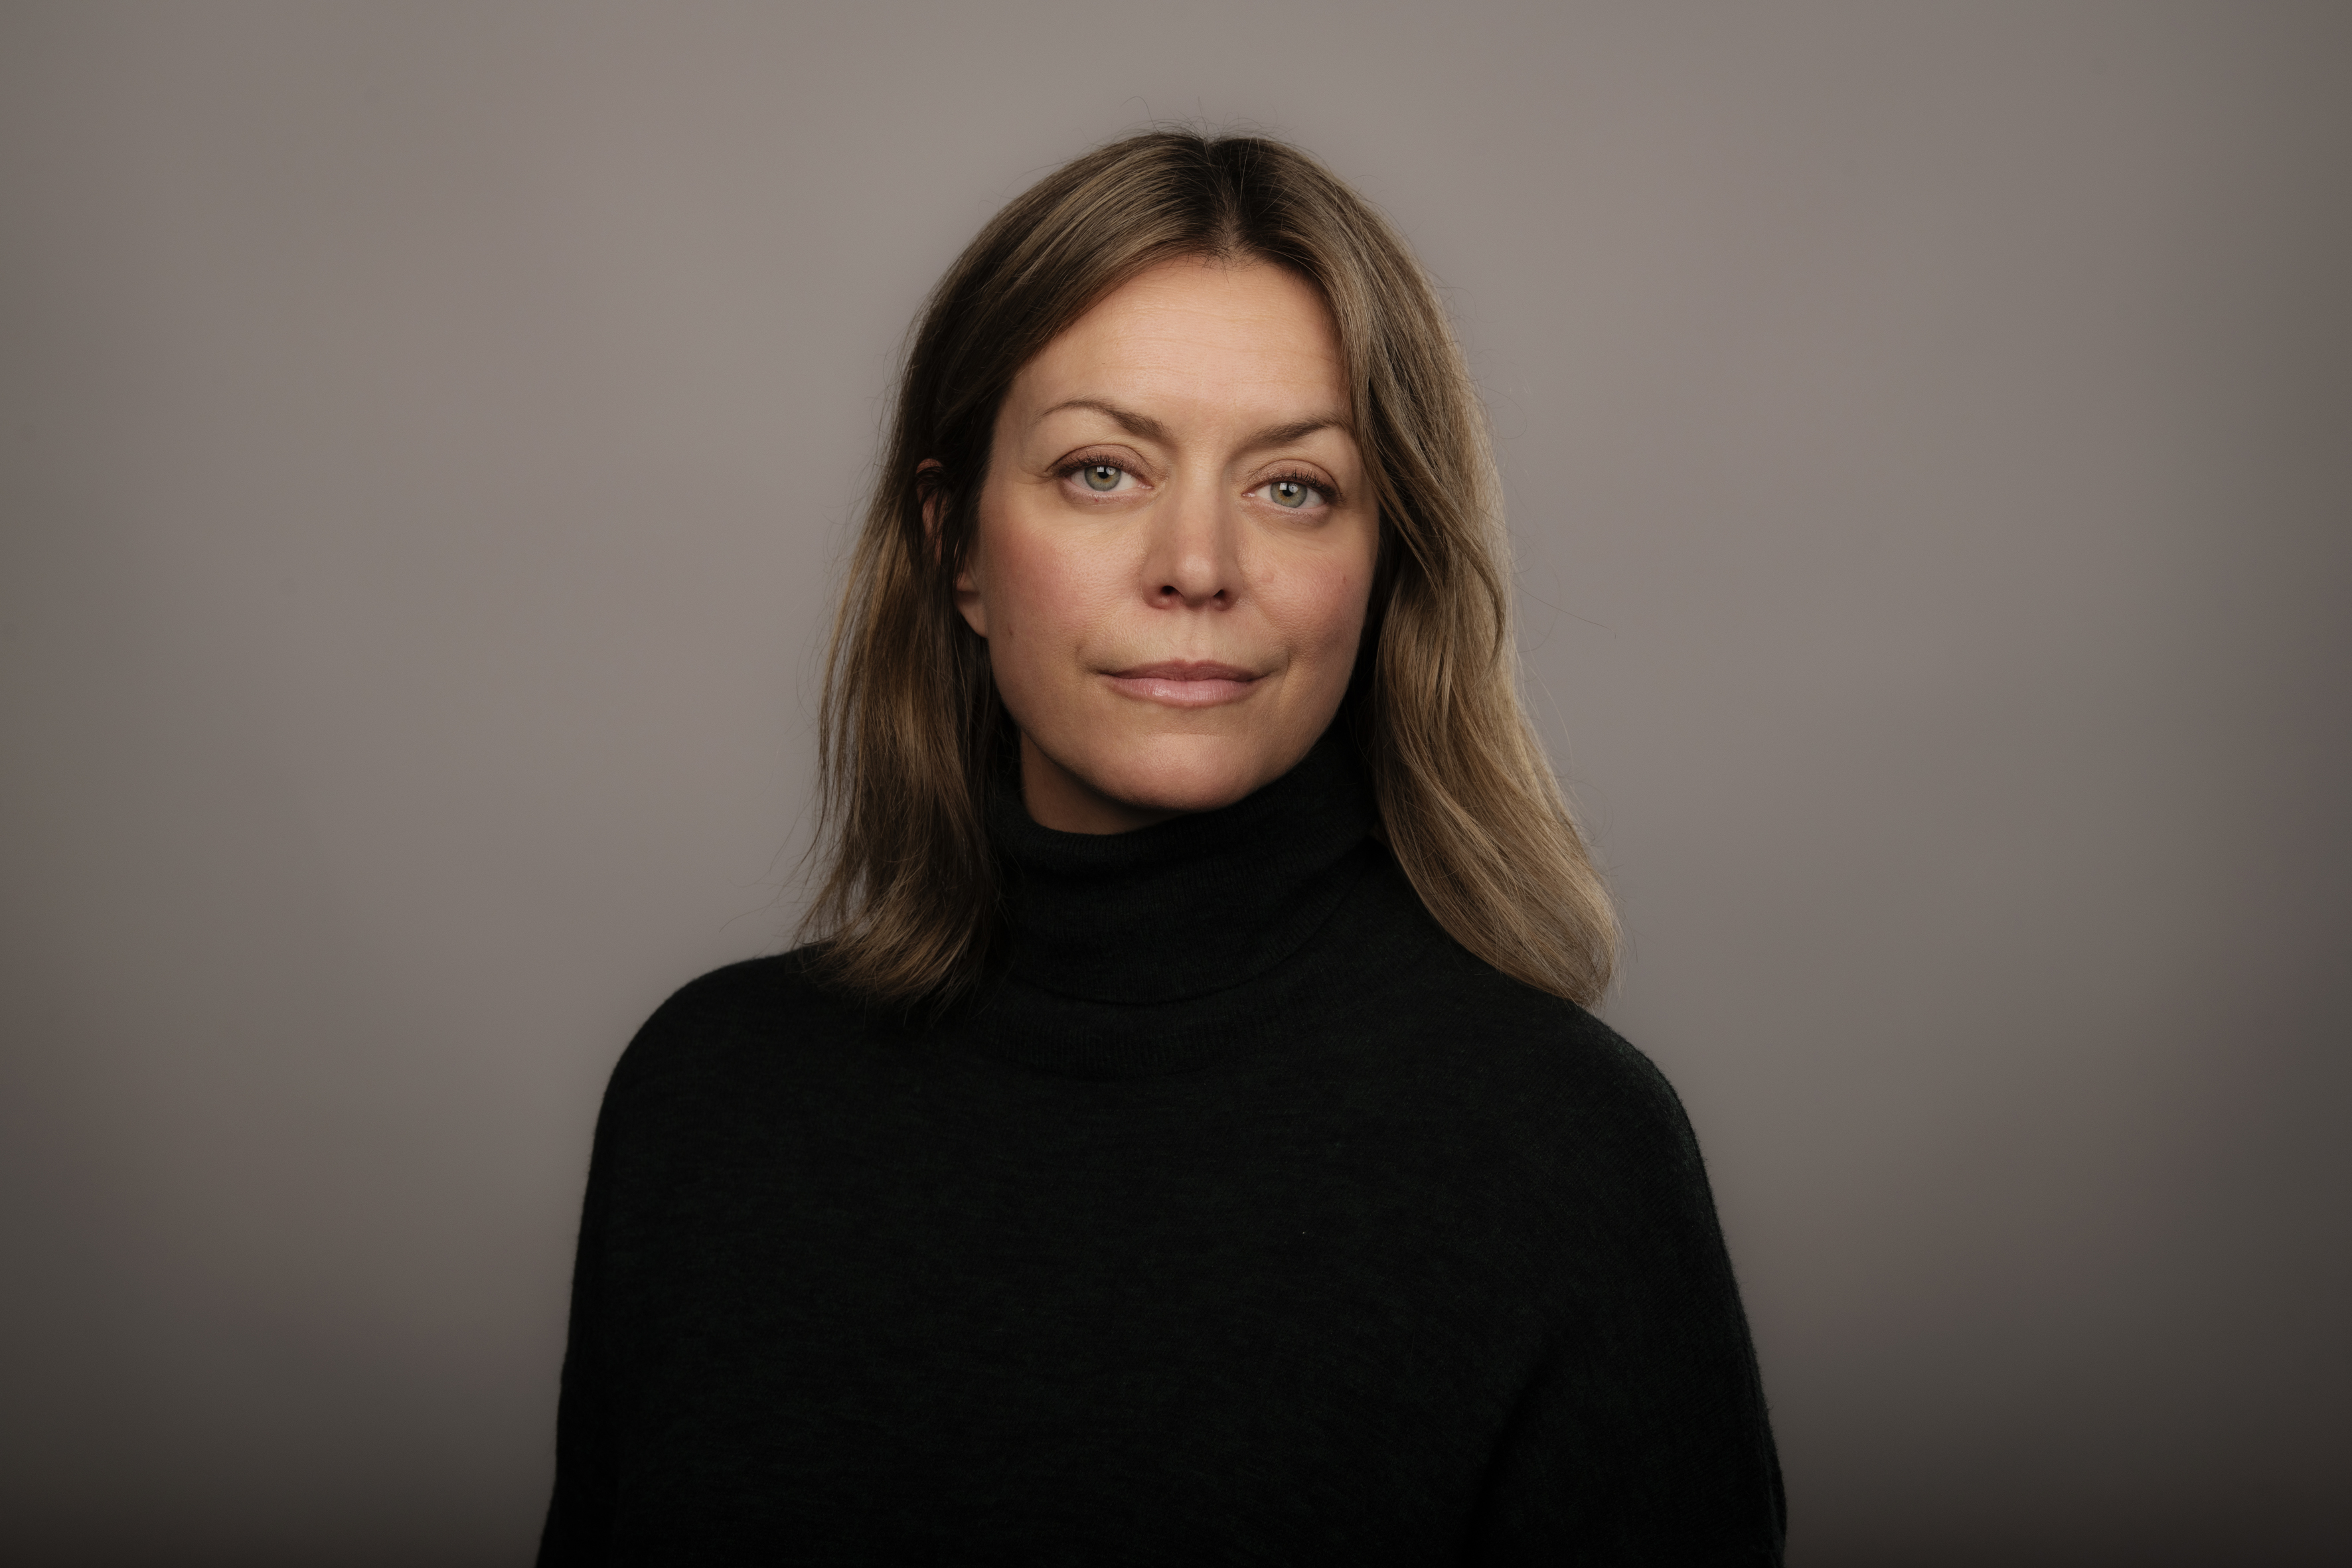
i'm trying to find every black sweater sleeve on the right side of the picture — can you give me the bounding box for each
[1472,1042,1785,1568]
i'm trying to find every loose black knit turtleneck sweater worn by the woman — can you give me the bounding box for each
[538,740,1780,1565]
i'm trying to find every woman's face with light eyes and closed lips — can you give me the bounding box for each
[955,259,1378,832]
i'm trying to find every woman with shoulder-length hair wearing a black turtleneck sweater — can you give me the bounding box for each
[541,134,1780,1563]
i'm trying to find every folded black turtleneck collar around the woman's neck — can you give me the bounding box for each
[990,726,1373,1004]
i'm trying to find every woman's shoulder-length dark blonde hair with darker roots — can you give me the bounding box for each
[802,131,1616,1004]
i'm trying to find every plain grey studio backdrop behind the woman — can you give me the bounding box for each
[0,0,2352,1568]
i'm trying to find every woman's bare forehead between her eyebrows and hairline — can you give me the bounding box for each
[1014,256,1348,414]
